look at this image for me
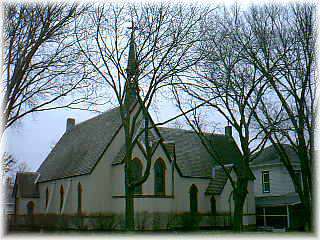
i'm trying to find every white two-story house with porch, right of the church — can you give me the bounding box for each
[250,145,303,229]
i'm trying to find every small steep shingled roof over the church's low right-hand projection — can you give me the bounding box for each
[205,167,232,195]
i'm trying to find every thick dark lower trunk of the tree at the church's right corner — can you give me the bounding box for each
[232,180,248,232]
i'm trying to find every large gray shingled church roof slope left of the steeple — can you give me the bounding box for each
[38,108,121,182]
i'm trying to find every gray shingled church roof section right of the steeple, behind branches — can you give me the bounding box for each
[158,127,241,177]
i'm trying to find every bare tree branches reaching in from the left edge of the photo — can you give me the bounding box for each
[1,3,97,139]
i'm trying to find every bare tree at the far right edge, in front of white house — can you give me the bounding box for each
[234,4,316,229]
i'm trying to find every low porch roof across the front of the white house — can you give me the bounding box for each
[256,192,301,207]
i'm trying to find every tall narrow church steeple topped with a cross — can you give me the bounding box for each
[125,21,139,104]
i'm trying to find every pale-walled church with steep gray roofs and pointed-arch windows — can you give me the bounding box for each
[13,26,255,229]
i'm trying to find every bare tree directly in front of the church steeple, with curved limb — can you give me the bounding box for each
[75,3,210,230]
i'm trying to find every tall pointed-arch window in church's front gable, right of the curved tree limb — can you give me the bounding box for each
[154,158,166,195]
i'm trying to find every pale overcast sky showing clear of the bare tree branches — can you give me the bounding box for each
[5,1,320,171]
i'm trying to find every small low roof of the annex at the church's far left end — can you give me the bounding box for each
[13,172,39,198]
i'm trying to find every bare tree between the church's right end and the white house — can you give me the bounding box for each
[171,8,268,231]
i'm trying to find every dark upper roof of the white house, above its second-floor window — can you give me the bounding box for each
[251,144,300,166]
